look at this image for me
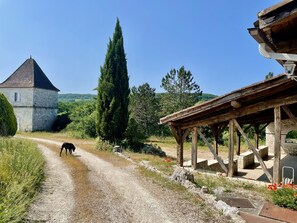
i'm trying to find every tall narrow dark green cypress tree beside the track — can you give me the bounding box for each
[97,19,130,142]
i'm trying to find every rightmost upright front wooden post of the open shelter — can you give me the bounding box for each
[273,106,282,184]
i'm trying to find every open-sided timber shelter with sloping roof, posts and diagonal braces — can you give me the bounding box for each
[160,75,297,182]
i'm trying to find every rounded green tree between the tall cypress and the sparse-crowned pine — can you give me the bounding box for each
[129,83,160,136]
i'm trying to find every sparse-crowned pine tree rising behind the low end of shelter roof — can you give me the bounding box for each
[161,66,202,114]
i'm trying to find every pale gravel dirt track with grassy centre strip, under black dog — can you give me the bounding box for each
[23,138,229,223]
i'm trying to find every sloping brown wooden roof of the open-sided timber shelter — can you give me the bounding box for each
[160,75,297,129]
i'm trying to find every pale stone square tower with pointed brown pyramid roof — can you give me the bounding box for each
[0,57,59,131]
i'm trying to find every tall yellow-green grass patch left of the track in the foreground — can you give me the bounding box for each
[0,138,44,222]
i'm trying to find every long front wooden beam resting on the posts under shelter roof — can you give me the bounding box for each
[180,95,297,129]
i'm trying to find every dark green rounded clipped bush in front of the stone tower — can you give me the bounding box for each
[0,93,17,136]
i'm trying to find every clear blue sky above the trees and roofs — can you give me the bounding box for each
[0,0,283,95]
